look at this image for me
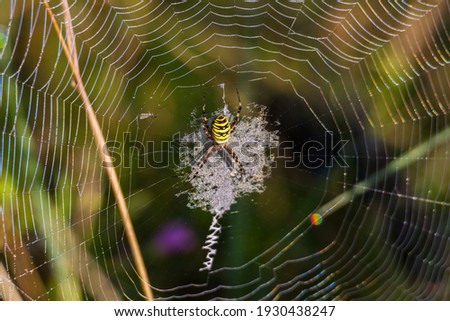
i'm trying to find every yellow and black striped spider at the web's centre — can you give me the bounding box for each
[191,90,245,180]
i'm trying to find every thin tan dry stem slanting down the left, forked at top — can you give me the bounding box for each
[43,0,153,300]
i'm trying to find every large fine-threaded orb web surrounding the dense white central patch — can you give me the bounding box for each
[0,0,450,300]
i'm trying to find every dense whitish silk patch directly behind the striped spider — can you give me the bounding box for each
[177,104,279,214]
